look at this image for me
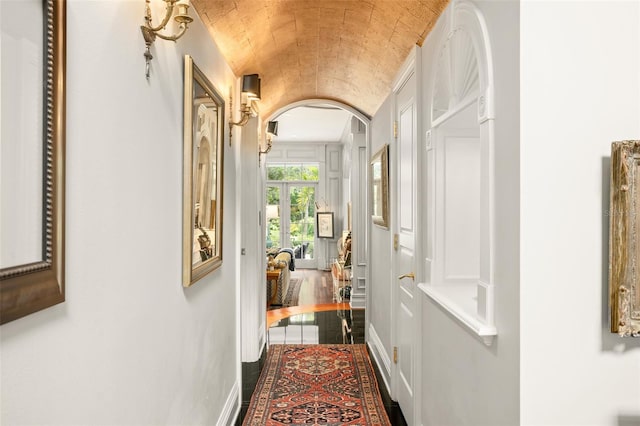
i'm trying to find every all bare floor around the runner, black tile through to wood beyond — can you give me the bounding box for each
[236,269,407,426]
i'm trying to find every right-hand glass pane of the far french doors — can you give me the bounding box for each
[289,185,316,268]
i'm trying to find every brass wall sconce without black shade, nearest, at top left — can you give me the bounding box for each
[140,0,193,80]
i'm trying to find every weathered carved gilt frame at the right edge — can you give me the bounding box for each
[609,141,640,337]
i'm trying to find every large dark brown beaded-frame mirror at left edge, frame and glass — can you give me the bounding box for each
[0,0,66,324]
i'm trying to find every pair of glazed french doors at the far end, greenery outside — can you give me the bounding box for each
[266,182,318,269]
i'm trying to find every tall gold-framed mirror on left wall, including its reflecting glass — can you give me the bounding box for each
[182,55,224,287]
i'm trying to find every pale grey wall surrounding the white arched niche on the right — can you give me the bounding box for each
[419,1,519,426]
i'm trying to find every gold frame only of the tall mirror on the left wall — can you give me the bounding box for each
[182,55,225,288]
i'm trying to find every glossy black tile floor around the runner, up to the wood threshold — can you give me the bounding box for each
[236,309,407,426]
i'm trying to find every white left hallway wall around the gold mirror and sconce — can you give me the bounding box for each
[0,0,239,425]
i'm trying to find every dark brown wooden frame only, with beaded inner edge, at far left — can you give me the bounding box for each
[0,0,67,324]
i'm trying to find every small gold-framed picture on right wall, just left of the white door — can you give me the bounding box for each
[370,144,389,228]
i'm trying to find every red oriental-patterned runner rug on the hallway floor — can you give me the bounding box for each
[242,345,391,426]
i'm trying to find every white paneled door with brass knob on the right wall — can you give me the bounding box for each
[392,70,417,425]
